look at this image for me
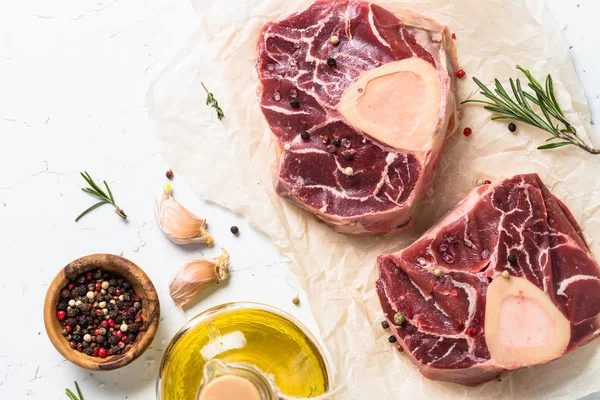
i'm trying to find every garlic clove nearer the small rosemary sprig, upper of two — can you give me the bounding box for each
[154,183,214,247]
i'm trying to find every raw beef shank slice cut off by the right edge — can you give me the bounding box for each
[376,174,600,385]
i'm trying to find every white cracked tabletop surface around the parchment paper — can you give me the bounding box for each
[0,0,600,400]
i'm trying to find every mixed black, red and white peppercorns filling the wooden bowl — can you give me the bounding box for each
[56,269,143,358]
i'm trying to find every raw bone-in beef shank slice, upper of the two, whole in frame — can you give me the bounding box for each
[257,0,458,234]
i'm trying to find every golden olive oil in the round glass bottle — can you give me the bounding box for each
[157,303,330,400]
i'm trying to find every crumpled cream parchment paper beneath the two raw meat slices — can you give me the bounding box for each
[147,0,600,400]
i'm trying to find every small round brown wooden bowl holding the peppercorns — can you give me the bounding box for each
[44,254,160,371]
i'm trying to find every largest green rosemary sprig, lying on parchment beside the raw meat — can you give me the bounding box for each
[461,65,600,154]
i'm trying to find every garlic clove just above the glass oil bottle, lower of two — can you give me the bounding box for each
[169,249,229,310]
